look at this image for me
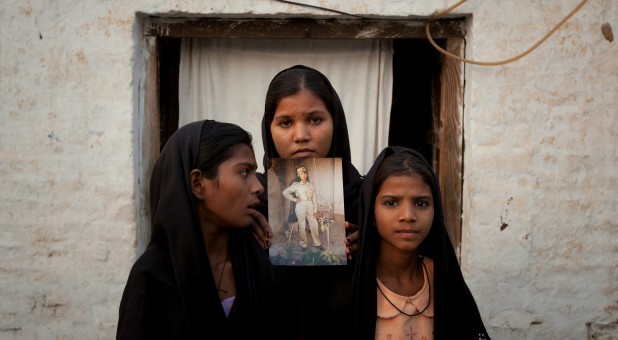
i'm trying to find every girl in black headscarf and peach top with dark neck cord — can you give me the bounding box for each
[340,146,489,339]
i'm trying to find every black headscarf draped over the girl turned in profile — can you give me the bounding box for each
[117,120,284,339]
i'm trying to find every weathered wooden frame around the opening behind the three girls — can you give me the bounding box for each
[136,15,466,254]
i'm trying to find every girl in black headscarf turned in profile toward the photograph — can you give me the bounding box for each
[117,120,293,339]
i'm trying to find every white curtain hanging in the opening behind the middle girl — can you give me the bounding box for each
[179,38,393,174]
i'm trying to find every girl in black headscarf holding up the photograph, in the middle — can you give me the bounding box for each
[254,65,362,339]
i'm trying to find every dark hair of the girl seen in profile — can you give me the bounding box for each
[194,120,253,179]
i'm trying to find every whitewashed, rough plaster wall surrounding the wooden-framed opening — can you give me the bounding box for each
[0,0,618,339]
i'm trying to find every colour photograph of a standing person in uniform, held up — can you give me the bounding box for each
[267,158,347,266]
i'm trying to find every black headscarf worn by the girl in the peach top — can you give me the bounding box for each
[348,146,489,340]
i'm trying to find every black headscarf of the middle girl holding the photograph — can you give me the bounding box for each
[262,65,362,224]
